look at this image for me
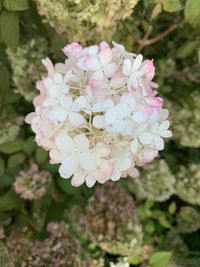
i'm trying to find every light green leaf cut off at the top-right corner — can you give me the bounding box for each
[184,0,200,27]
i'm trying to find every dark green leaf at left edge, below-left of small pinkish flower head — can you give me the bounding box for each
[0,191,23,211]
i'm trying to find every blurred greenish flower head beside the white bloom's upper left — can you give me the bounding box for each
[7,38,48,101]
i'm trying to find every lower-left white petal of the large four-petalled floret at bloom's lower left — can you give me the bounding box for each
[59,156,77,178]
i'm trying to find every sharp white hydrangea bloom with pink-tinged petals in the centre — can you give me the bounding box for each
[26,41,172,187]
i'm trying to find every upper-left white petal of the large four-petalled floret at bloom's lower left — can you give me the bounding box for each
[55,133,74,154]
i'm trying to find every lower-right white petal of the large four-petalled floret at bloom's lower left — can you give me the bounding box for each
[79,152,96,172]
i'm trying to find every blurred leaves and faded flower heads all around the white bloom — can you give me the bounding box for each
[0,0,200,267]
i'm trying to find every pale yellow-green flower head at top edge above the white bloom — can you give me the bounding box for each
[36,0,138,43]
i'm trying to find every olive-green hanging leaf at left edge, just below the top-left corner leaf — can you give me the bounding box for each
[1,10,19,47]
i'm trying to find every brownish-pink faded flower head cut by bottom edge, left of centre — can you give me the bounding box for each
[26,222,92,267]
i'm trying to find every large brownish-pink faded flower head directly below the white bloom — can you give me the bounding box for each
[69,182,143,256]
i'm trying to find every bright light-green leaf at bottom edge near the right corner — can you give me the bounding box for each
[149,251,172,267]
